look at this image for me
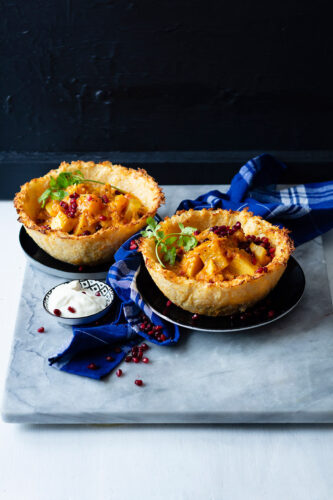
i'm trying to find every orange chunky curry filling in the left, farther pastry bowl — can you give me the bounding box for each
[37,182,147,236]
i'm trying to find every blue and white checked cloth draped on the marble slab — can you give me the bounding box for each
[49,154,333,379]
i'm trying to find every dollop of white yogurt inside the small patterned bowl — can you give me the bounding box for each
[48,280,106,318]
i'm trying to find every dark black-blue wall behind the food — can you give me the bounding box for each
[0,0,333,194]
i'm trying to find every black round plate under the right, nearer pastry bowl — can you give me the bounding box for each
[137,257,305,332]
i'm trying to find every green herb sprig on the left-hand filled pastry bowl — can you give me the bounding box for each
[38,170,125,208]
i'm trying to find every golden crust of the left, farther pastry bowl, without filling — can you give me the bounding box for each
[14,161,164,265]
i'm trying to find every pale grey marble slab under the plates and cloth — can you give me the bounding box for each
[2,187,333,424]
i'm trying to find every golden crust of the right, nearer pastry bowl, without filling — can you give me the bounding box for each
[140,209,294,316]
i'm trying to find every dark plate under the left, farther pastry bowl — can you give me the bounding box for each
[19,226,112,280]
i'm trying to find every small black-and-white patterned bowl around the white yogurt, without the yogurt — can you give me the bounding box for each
[43,279,114,326]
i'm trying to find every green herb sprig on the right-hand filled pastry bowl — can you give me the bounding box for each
[141,217,198,267]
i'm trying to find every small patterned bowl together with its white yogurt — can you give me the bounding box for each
[43,279,114,325]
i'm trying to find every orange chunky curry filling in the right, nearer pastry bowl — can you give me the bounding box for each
[167,222,275,283]
